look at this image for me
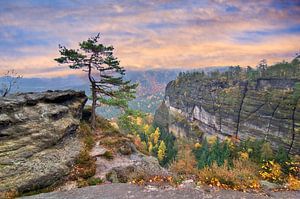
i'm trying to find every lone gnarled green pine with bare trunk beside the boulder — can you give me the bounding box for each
[55,34,137,128]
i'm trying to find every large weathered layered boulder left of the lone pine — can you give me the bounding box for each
[0,90,87,192]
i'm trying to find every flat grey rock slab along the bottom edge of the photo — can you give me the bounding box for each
[24,184,300,199]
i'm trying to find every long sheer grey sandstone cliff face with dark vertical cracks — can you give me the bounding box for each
[155,78,300,154]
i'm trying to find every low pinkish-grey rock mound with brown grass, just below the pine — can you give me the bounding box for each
[90,129,169,183]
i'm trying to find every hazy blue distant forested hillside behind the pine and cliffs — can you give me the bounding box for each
[0,67,227,118]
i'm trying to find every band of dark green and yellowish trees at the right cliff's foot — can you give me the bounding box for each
[193,139,290,171]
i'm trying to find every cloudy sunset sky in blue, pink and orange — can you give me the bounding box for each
[0,0,300,77]
